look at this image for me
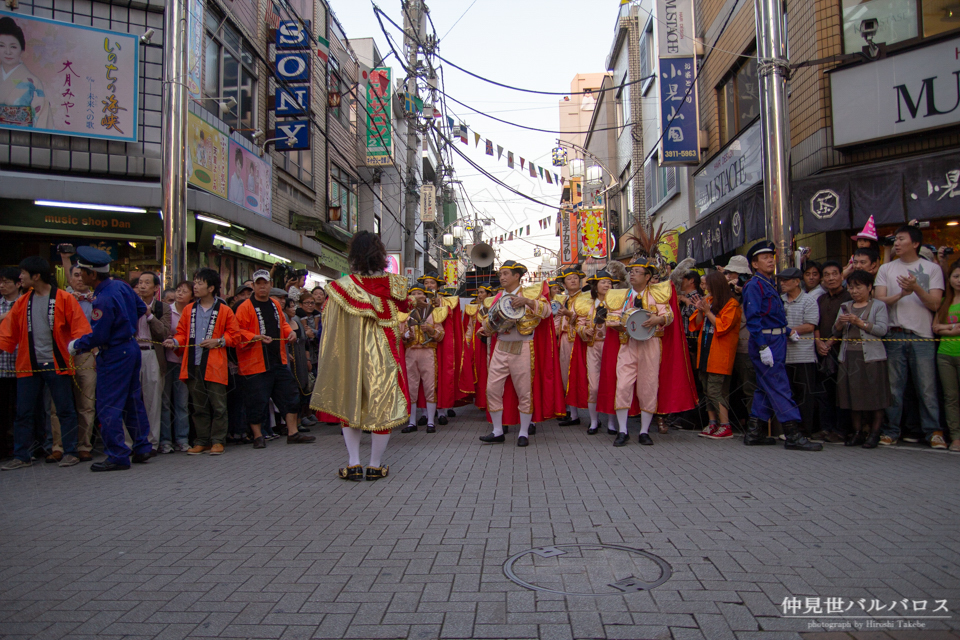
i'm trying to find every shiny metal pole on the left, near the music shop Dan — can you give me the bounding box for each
[160,0,187,287]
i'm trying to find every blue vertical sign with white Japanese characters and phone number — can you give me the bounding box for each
[660,56,700,165]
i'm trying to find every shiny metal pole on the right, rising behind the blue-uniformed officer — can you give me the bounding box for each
[755,0,793,269]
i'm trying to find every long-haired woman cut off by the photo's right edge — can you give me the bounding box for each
[933,260,960,451]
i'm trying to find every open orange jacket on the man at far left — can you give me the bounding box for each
[0,287,90,378]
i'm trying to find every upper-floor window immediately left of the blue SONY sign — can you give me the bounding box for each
[203,6,257,139]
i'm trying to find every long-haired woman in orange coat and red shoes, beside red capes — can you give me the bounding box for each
[690,271,740,440]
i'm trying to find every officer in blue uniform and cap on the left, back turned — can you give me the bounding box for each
[70,247,151,471]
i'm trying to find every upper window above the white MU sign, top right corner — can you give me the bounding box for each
[841,0,960,53]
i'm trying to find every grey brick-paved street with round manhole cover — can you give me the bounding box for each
[0,409,960,640]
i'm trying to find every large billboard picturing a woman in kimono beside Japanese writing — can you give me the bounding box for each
[0,11,140,142]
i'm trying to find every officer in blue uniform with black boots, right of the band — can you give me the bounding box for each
[743,240,823,451]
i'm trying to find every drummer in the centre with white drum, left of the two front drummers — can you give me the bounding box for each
[480,260,563,447]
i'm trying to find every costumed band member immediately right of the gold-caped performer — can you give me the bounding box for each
[400,285,449,433]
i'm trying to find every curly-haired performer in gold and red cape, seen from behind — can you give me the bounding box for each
[310,231,410,481]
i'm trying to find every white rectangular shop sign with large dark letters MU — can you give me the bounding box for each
[830,38,960,147]
